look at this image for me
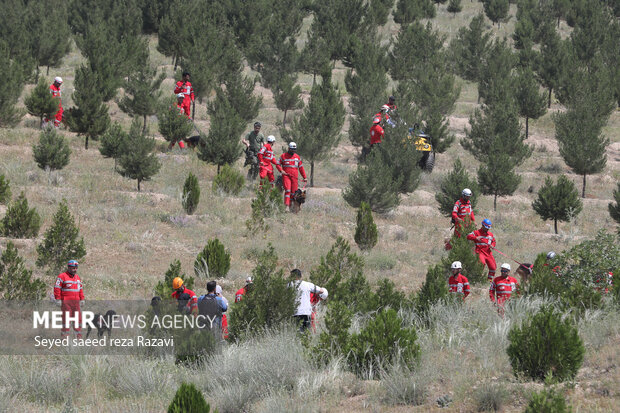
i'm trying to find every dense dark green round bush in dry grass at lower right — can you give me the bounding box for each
[507,306,585,381]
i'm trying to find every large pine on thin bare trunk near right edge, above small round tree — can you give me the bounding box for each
[553,83,610,198]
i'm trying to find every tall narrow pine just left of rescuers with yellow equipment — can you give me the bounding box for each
[344,34,388,152]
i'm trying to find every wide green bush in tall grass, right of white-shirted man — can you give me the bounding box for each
[347,309,420,376]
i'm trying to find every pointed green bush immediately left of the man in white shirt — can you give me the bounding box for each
[228,244,297,340]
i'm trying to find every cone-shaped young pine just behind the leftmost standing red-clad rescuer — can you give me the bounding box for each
[36,198,86,275]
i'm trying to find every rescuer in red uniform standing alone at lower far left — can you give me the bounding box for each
[54,260,84,338]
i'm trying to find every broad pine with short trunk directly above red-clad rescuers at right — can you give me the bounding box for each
[461,97,532,209]
